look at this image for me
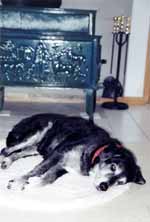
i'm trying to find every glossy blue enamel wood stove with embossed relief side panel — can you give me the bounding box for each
[0,6,101,119]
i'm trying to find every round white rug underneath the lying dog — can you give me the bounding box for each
[0,141,130,212]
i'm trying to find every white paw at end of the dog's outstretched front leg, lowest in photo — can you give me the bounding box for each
[7,177,29,190]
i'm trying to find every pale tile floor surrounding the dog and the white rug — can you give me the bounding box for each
[0,103,150,222]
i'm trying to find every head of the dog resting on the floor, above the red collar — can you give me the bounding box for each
[91,141,146,191]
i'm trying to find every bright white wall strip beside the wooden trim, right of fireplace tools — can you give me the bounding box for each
[125,0,150,97]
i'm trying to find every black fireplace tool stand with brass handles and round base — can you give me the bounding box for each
[102,16,130,110]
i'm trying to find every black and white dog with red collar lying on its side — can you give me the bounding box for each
[0,114,145,191]
